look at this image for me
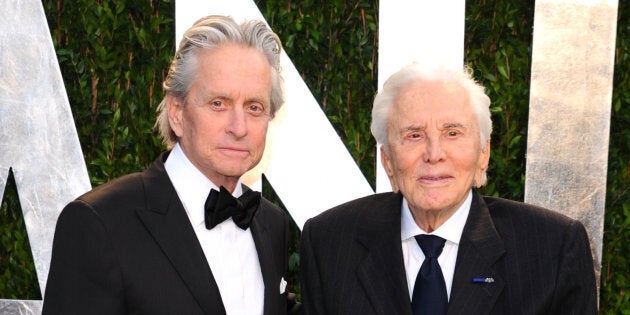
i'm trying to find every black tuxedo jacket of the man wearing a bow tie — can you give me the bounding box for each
[43,153,288,315]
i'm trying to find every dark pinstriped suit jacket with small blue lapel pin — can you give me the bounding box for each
[300,192,597,315]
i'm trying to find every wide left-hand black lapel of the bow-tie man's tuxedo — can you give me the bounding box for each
[137,154,225,314]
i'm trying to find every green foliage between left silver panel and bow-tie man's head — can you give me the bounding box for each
[44,0,175,185]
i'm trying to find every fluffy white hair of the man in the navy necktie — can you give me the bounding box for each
[370,63,492,184]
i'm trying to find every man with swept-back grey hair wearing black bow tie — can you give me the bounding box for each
[43,16,298,315]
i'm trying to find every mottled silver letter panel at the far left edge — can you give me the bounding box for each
[0,0,91,314]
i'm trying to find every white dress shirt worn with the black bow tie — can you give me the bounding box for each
[164,144,265,314]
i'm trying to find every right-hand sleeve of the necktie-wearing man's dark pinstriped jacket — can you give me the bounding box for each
[551,221,597,314]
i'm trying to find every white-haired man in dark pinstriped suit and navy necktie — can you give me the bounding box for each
[300,64,597,315]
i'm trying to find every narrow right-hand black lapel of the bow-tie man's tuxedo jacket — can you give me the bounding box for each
[249,198,282,314]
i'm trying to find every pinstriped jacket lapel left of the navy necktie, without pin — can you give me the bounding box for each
[357,194,411,314]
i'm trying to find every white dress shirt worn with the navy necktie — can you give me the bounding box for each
[400,190,472,300]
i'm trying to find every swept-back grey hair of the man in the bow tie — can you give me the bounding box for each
[155,15,284,149]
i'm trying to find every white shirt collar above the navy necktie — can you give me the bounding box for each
[400,189,472,245]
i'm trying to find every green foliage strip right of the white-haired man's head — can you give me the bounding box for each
[465,0,534,200]
